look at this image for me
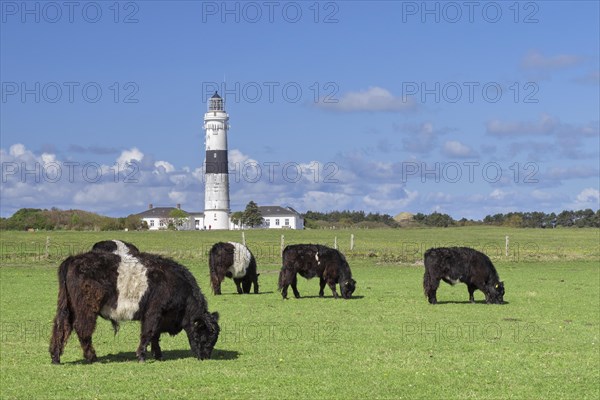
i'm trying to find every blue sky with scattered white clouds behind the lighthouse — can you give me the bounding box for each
[0,1,600,219]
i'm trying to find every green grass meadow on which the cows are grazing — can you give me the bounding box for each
[0,227,600,399]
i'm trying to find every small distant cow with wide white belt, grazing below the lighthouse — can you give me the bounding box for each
[208,242,260,294]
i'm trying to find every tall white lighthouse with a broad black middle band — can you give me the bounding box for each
[204,92,229,229]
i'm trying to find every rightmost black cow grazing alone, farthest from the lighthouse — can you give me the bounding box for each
[423,247,504,304]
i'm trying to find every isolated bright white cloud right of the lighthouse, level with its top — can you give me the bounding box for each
[318,86,416,112]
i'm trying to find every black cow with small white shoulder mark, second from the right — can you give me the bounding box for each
[279,244,356,299]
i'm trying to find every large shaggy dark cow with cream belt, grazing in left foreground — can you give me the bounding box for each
[50,242,220,364]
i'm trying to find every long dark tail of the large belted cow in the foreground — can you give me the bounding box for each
[50,258,73,364]
